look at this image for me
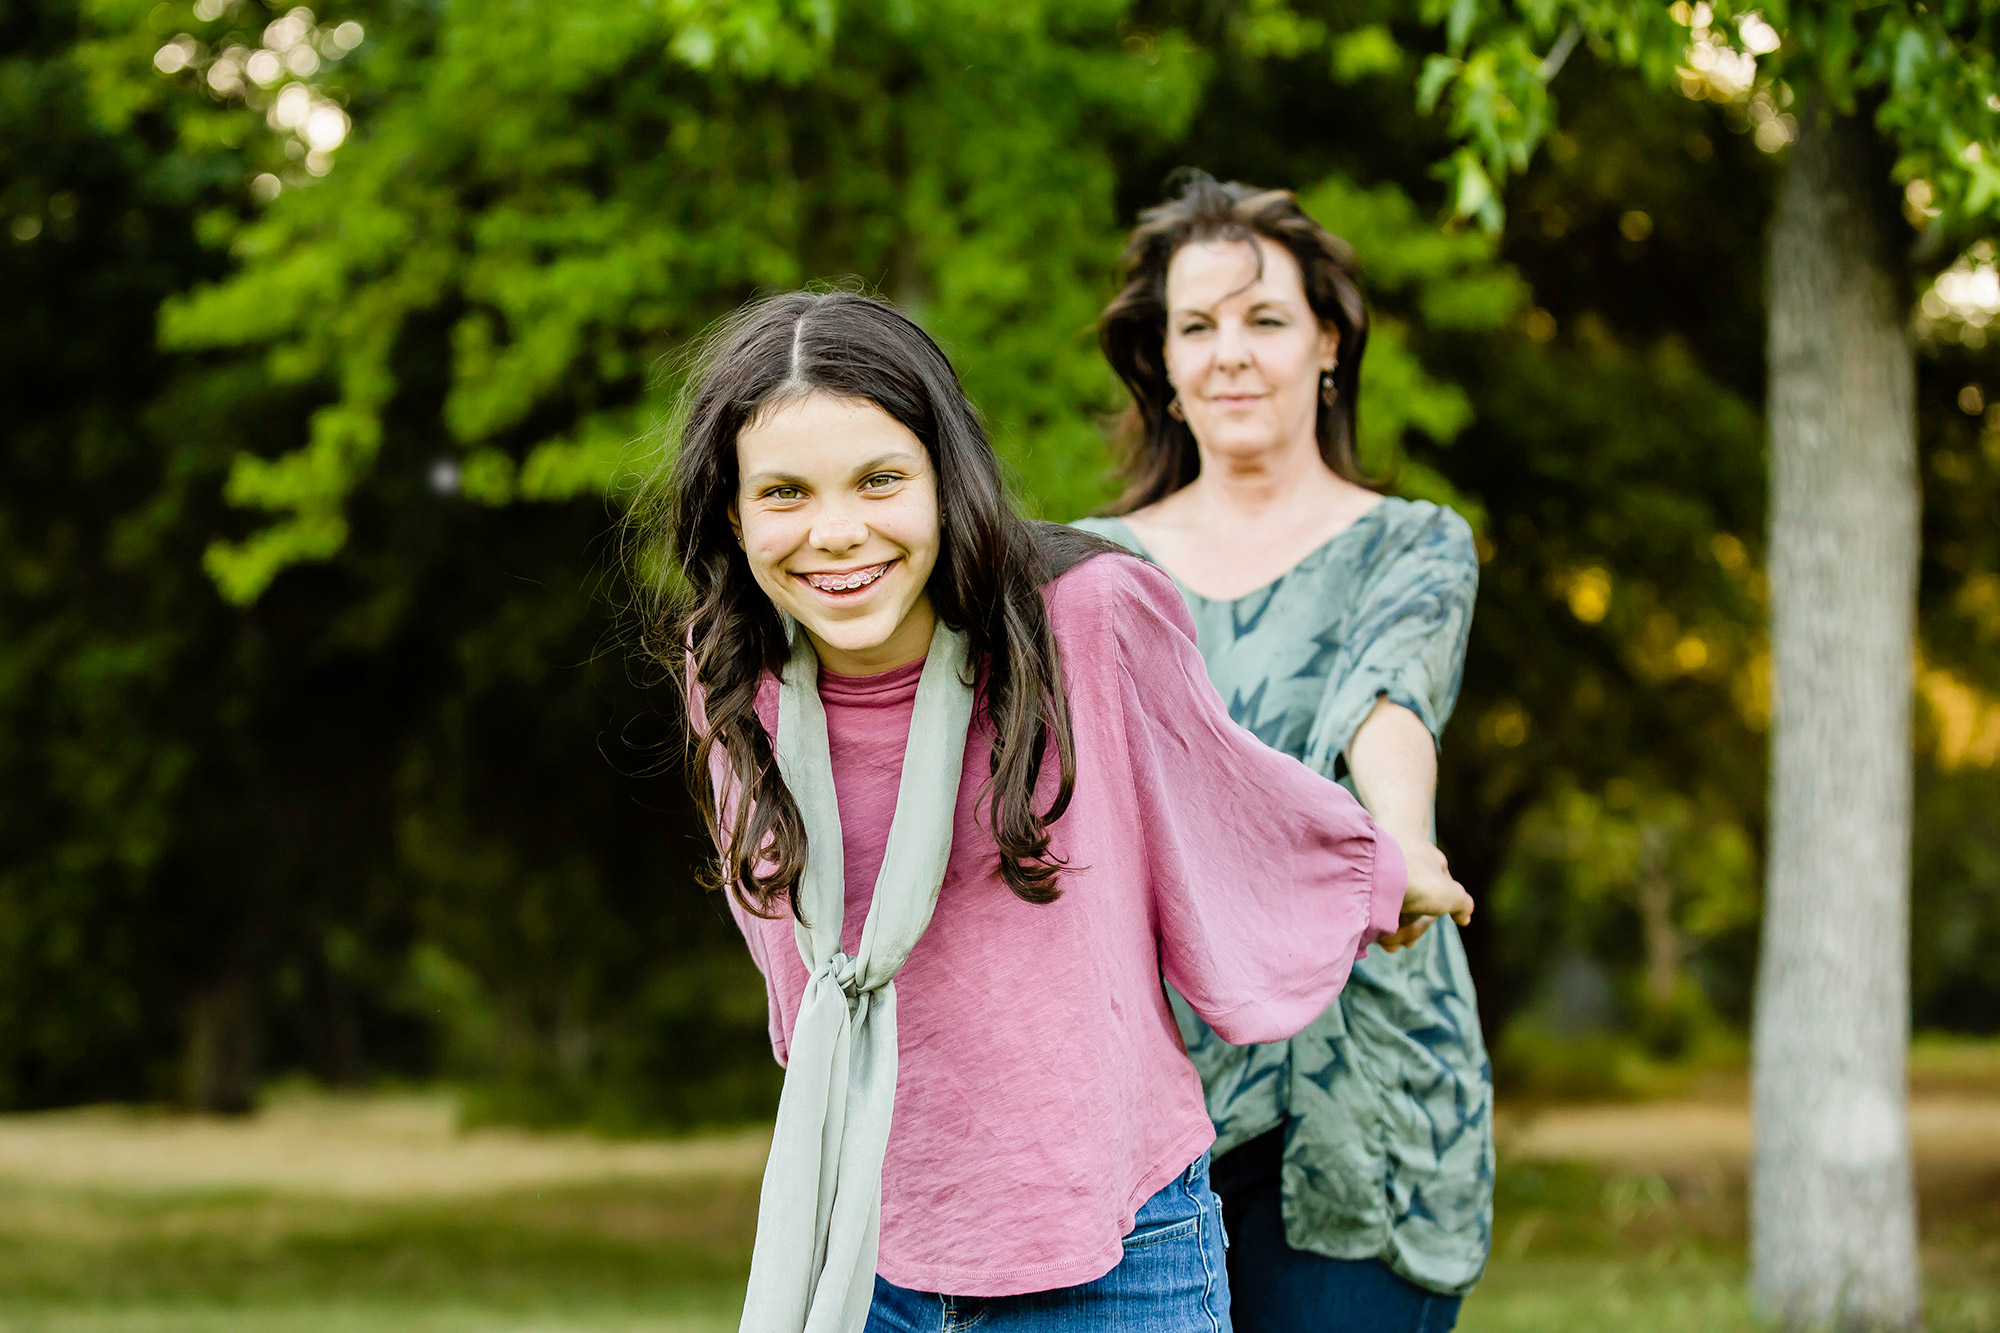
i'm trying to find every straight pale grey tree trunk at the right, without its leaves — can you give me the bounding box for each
[1750,106,1920,1329]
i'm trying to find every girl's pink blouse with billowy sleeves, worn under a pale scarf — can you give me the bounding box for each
[730,554,1404,1295]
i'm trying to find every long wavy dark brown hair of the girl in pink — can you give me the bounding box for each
[632,290,1116,917]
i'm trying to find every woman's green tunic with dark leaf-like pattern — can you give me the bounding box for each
[1076,498,1494,1293]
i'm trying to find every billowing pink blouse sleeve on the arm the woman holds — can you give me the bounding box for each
[1072,556,1404,1045]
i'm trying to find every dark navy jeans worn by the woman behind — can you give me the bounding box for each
[1212,1125,1460,1333]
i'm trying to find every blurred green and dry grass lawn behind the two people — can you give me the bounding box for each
[0,1080,2000,1333]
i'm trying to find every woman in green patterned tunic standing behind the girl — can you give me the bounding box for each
[1080,172,1492,1333]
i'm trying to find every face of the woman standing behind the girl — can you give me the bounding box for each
[1166,236,1340,458]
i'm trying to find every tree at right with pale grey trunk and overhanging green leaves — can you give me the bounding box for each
[1418,0,2000,1329]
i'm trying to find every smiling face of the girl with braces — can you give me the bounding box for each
[730,394,938,677]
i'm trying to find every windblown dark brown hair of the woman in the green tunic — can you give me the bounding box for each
[1098,170,1382,514]
